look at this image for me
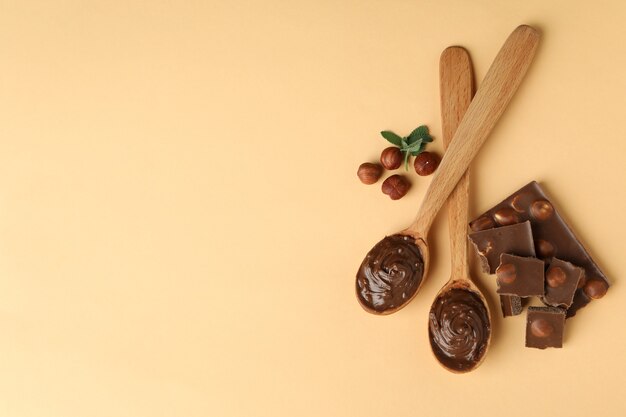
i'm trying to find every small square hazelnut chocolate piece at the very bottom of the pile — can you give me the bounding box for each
[526,307,565,349]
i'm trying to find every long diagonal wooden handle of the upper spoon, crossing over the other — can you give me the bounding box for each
[409,25,539,238]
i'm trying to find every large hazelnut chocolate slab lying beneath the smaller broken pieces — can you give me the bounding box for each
[470,181,609,317]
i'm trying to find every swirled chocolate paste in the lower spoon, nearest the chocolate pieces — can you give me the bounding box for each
[428,288,491,371]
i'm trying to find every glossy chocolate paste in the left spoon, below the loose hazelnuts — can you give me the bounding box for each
[356,235,424,312]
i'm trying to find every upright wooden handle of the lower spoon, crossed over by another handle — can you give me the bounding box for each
[439,46,474,279]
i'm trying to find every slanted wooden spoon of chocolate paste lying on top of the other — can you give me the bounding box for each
[356,25,539,314]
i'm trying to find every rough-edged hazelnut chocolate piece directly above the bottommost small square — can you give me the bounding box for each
[543,258,585,308]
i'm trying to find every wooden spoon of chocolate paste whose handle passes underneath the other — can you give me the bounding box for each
[428,46,491,373]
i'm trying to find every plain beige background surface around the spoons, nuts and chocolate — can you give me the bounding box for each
[0,0,626,417]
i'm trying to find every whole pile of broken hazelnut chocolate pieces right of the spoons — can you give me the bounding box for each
[469,181,609,349]
